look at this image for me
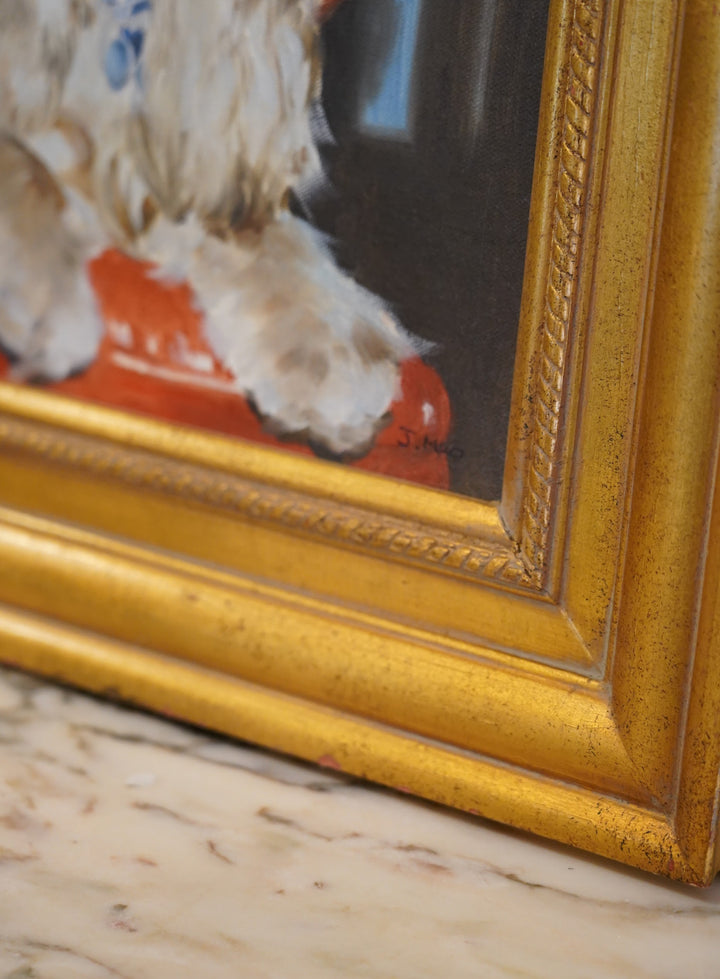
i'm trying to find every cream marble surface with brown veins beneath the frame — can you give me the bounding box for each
[0,671,720,979]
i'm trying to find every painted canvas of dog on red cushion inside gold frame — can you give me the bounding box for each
[0,0,547,499]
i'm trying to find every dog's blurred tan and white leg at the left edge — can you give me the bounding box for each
[0,135,102,380]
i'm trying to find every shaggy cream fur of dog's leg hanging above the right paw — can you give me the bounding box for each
[127,0,320,234]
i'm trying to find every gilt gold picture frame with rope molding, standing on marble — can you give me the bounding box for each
[0,0,720,884]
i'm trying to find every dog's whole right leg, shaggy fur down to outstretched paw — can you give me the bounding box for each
[128,0,422,455]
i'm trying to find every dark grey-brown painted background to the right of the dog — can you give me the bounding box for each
[312,0,548,500]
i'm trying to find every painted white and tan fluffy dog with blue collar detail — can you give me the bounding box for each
[0,0,413,455]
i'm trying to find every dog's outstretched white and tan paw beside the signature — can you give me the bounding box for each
[171,215,416,456]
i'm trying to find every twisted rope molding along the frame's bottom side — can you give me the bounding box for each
[0,417,533,587]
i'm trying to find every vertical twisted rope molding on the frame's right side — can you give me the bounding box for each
[520,0,605,587]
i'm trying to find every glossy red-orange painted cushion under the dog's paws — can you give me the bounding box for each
[0,250,450,489]
